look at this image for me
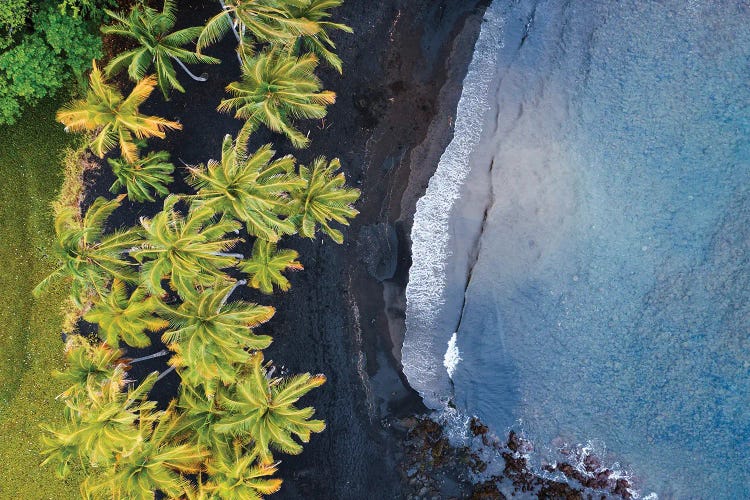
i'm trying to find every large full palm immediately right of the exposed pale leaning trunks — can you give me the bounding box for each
[162,283,275,389]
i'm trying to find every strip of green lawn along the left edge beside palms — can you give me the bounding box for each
[0,101,80,500]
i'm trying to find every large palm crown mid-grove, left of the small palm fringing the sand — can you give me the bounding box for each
[130,195,242,299]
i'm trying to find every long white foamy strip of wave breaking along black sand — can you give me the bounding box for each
[402,1,503,408]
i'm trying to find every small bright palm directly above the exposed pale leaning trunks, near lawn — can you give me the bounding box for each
[83,280,169,347]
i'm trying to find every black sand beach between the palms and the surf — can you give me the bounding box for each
[82,0,488,499]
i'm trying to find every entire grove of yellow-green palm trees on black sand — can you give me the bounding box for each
[36,0,359,499]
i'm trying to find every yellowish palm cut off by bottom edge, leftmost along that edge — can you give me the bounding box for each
[85,404,208,500]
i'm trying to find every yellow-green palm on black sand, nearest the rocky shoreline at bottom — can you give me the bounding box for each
[216,352,326,464]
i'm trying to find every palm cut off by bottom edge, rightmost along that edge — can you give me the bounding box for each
[200,446,282,500]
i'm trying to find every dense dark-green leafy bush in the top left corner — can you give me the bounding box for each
[0,0,101,125]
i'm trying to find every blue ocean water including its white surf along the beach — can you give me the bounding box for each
[403,0,750,499]
